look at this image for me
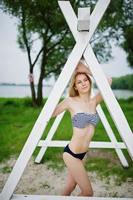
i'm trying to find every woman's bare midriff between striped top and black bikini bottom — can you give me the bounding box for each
[69,124,95,153]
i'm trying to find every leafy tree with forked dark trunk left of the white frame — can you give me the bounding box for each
[1,0,73,105]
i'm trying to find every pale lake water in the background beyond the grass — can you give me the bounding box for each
[0,85,133,99]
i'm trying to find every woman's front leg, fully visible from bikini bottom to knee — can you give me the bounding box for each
[63,152,93,196]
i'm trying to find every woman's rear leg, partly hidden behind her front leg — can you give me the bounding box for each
[62,171,76,196]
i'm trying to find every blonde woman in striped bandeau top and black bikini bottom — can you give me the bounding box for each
[52,62,111,196]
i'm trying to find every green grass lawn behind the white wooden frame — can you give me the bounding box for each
[0,98,133,182]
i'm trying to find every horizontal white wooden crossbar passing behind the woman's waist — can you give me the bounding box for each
[38,140,126,149]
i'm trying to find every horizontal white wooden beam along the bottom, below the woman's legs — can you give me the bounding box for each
[11,194,133,200]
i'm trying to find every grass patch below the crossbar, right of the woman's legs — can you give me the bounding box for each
[86,150,133,185]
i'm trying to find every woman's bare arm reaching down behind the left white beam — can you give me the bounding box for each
[52,98,69,117]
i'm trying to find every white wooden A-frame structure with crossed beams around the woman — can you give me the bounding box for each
[0,0,133,200]
